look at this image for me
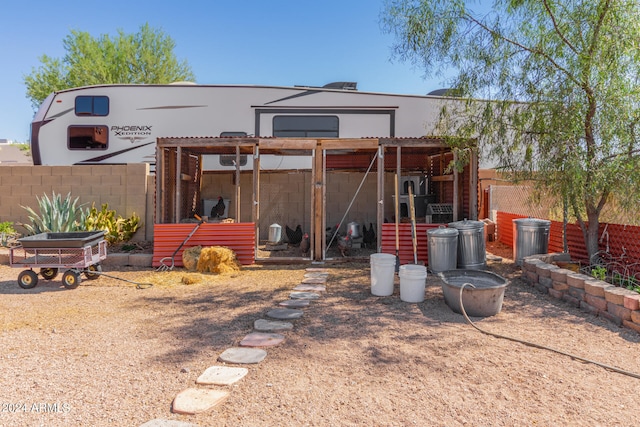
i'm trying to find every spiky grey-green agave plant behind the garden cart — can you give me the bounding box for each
[22,191,87,234]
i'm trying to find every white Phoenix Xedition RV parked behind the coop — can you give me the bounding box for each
[31,82,450,170]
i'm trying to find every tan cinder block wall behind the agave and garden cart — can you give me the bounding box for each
[0,163,155,240]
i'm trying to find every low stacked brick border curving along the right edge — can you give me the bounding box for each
[522,253,640,333]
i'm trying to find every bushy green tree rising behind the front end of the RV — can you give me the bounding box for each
[24,24,195,108]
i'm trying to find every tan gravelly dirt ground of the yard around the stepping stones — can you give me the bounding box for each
[0,244,640,427]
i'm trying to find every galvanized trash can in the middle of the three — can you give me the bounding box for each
[449,219,487,270]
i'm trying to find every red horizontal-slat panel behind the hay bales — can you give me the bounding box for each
[153,222,256,267]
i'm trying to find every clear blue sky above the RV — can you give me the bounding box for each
[0,0,445,142]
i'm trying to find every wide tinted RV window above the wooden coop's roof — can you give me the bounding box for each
[273,116,338,138]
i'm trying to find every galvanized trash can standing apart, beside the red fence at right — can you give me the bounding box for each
[513,218,551,266]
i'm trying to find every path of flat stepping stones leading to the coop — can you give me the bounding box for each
[159,268,329,427]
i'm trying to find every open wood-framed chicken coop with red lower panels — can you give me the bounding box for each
[154,136,478,265]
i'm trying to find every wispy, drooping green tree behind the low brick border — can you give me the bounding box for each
[382,0,640,257]
